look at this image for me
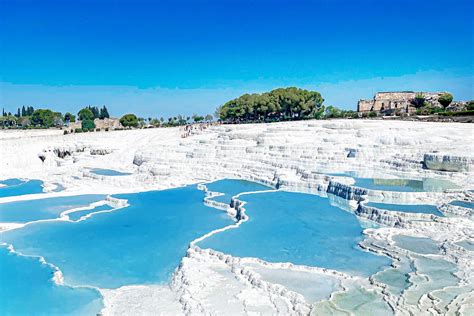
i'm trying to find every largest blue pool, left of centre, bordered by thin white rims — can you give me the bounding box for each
[0,186,233,288]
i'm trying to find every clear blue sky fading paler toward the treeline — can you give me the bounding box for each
[0,0,474,117]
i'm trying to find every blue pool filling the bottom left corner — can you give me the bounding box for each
[0,246,102,315]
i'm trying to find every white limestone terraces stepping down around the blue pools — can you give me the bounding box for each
[0,120,474,315]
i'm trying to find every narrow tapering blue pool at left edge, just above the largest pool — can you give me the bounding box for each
[0,194,105,223]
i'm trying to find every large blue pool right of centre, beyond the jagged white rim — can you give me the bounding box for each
[199,191,390,276]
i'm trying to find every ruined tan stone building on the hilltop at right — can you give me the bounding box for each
[357,91,446,115]
